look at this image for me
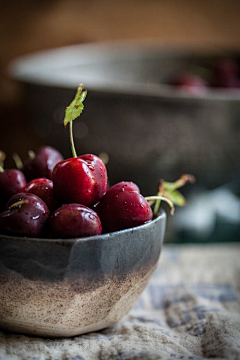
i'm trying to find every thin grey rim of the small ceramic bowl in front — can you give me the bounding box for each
[0,209,166,244]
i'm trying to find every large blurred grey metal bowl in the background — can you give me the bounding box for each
[9,42,240,194]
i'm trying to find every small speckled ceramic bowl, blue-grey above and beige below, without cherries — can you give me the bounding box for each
[0,211,166,337]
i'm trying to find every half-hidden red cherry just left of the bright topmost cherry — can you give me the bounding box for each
[21,178,58,211]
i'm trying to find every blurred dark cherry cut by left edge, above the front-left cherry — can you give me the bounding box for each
[0,169,27,208]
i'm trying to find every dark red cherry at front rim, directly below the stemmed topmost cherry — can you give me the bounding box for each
[50,204,102,238]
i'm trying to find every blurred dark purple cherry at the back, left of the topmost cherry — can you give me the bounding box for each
[22,146,63,181]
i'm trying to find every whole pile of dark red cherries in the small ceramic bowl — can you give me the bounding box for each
[0,146,153,238]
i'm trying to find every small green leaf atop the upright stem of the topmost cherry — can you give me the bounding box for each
[64,84,87,127]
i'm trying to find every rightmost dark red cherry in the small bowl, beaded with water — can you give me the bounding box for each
[96,181,153,232]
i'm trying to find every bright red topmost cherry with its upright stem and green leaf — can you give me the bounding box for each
[53,85,107,206]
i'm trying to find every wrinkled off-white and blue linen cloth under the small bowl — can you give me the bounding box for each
[0,243,240,360]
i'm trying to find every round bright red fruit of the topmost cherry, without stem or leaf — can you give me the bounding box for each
[53,154,107,206]
